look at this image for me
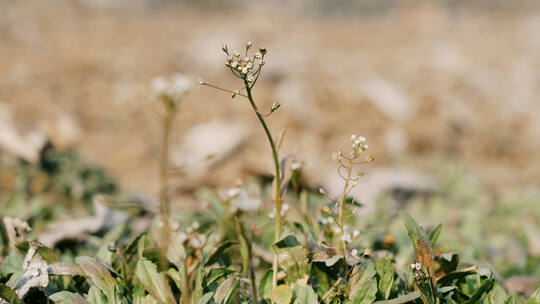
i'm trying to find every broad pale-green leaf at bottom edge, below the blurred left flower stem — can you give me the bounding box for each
[135,259,176,304]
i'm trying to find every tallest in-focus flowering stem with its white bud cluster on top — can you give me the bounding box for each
[199,42,282,288]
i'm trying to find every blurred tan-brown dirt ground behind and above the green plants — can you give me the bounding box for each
[0,0,540,207]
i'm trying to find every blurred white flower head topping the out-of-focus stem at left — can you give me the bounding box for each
[150,74,193,102]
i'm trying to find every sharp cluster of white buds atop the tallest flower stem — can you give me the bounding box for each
[221,42,266,82]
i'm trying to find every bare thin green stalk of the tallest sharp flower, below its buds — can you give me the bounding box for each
[244,77,281,288]
